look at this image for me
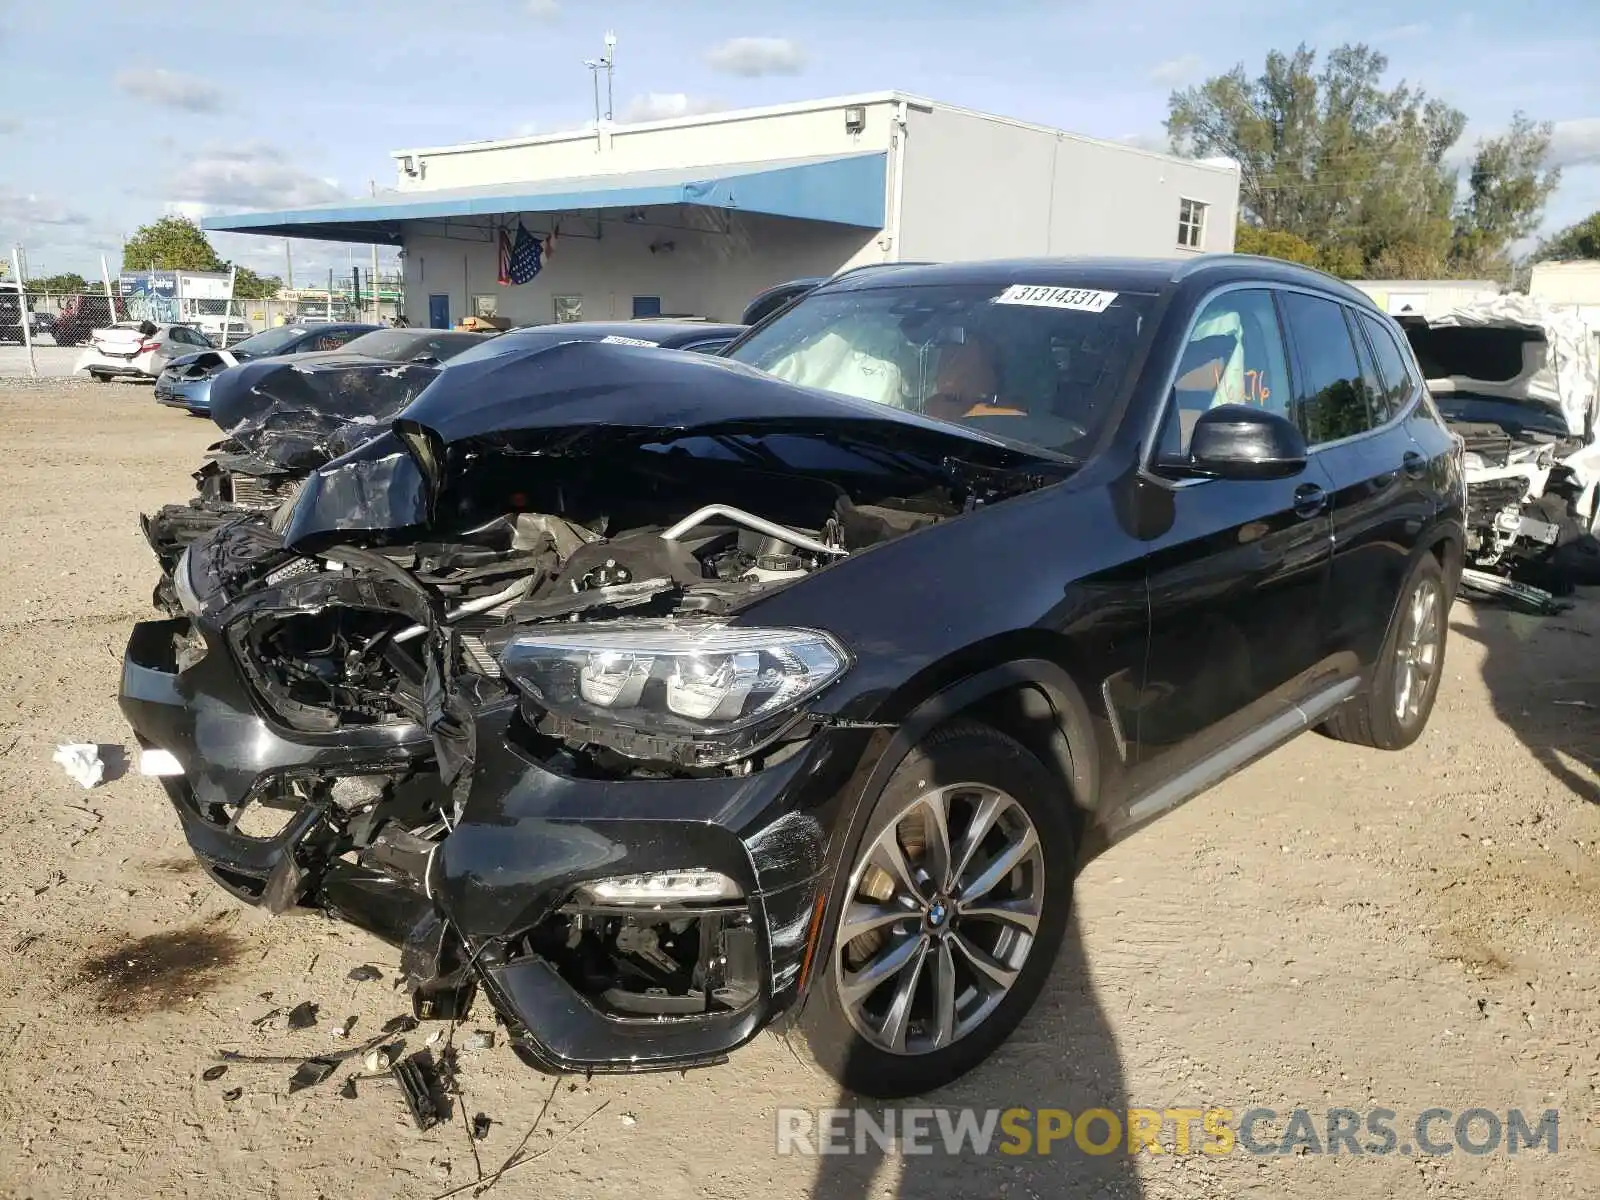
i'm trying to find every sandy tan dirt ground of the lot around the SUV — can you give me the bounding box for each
[0,381,1600,1200]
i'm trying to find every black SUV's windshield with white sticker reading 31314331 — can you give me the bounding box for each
[726,285,1154,454]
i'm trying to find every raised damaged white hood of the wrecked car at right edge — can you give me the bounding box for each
[1405,293,1600,437]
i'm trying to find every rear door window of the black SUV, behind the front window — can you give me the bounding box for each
[1280,291,1373,446]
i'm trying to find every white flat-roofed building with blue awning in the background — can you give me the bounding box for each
[203,93,1238,325]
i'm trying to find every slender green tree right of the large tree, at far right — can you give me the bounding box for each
[1451,112,1562,274]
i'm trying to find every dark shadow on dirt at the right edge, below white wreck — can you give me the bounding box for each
[1446,600,1600,805]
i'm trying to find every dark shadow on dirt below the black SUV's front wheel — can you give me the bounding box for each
[811,917,1142,1200]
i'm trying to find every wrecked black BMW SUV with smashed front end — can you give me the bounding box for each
[122,256,1464,1096]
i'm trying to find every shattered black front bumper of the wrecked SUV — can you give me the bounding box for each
[120,619,869,1072]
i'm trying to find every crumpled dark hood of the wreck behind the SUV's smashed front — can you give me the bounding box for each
[211,350,440,470]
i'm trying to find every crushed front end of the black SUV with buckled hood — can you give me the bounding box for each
[122,346,1062,1070]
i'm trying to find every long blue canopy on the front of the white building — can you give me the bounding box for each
[200,150,888,245]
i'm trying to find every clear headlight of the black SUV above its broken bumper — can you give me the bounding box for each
[501,621,850,748]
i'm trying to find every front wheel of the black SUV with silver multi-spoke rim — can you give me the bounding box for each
[792,720,1075,1099]
